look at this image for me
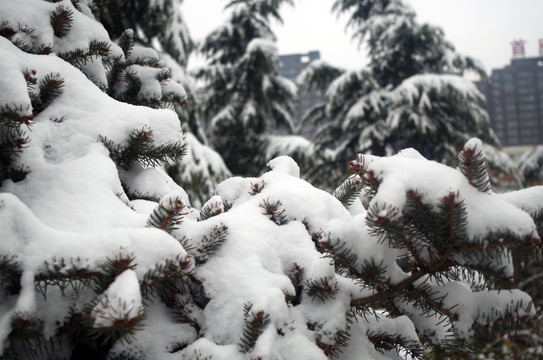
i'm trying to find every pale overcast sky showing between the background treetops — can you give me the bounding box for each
[183,0,543,72]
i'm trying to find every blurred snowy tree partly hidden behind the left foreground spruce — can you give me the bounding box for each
[93,0,230,207]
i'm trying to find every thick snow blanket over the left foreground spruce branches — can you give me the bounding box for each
[0,26,189,356]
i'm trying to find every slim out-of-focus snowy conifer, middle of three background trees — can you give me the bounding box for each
[199,0,295,175]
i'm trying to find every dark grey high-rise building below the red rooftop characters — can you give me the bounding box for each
[477,54,543,146]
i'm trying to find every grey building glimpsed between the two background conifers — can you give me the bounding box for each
[279,51,324,138]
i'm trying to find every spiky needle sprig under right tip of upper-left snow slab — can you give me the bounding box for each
[100,127,185,169]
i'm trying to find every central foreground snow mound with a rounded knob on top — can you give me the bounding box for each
[178,164,394,360]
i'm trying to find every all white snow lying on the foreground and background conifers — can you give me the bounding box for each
[0,0,543,360]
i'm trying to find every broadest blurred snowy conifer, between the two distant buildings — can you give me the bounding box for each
[302,0,510,190]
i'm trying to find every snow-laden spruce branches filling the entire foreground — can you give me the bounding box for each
[0,1,543,360]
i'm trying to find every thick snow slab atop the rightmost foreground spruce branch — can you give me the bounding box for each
[357,150,537,238]
